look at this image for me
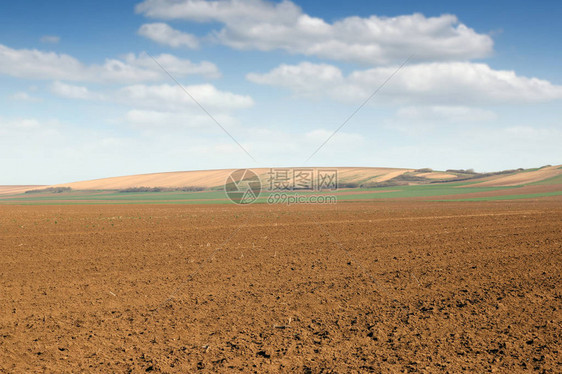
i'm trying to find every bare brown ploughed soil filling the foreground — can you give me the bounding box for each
[0,198,562,373]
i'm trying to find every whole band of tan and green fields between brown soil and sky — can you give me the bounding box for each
[0,166,562,205]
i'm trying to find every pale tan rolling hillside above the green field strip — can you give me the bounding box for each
[5,165,562,195]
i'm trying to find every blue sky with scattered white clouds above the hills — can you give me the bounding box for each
[0,0,562,184]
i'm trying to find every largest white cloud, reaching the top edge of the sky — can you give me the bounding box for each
[136,0,493,65]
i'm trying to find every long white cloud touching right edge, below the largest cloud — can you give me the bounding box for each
[247,62,562,105]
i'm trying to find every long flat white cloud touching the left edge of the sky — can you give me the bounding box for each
[0,44,219,83]
